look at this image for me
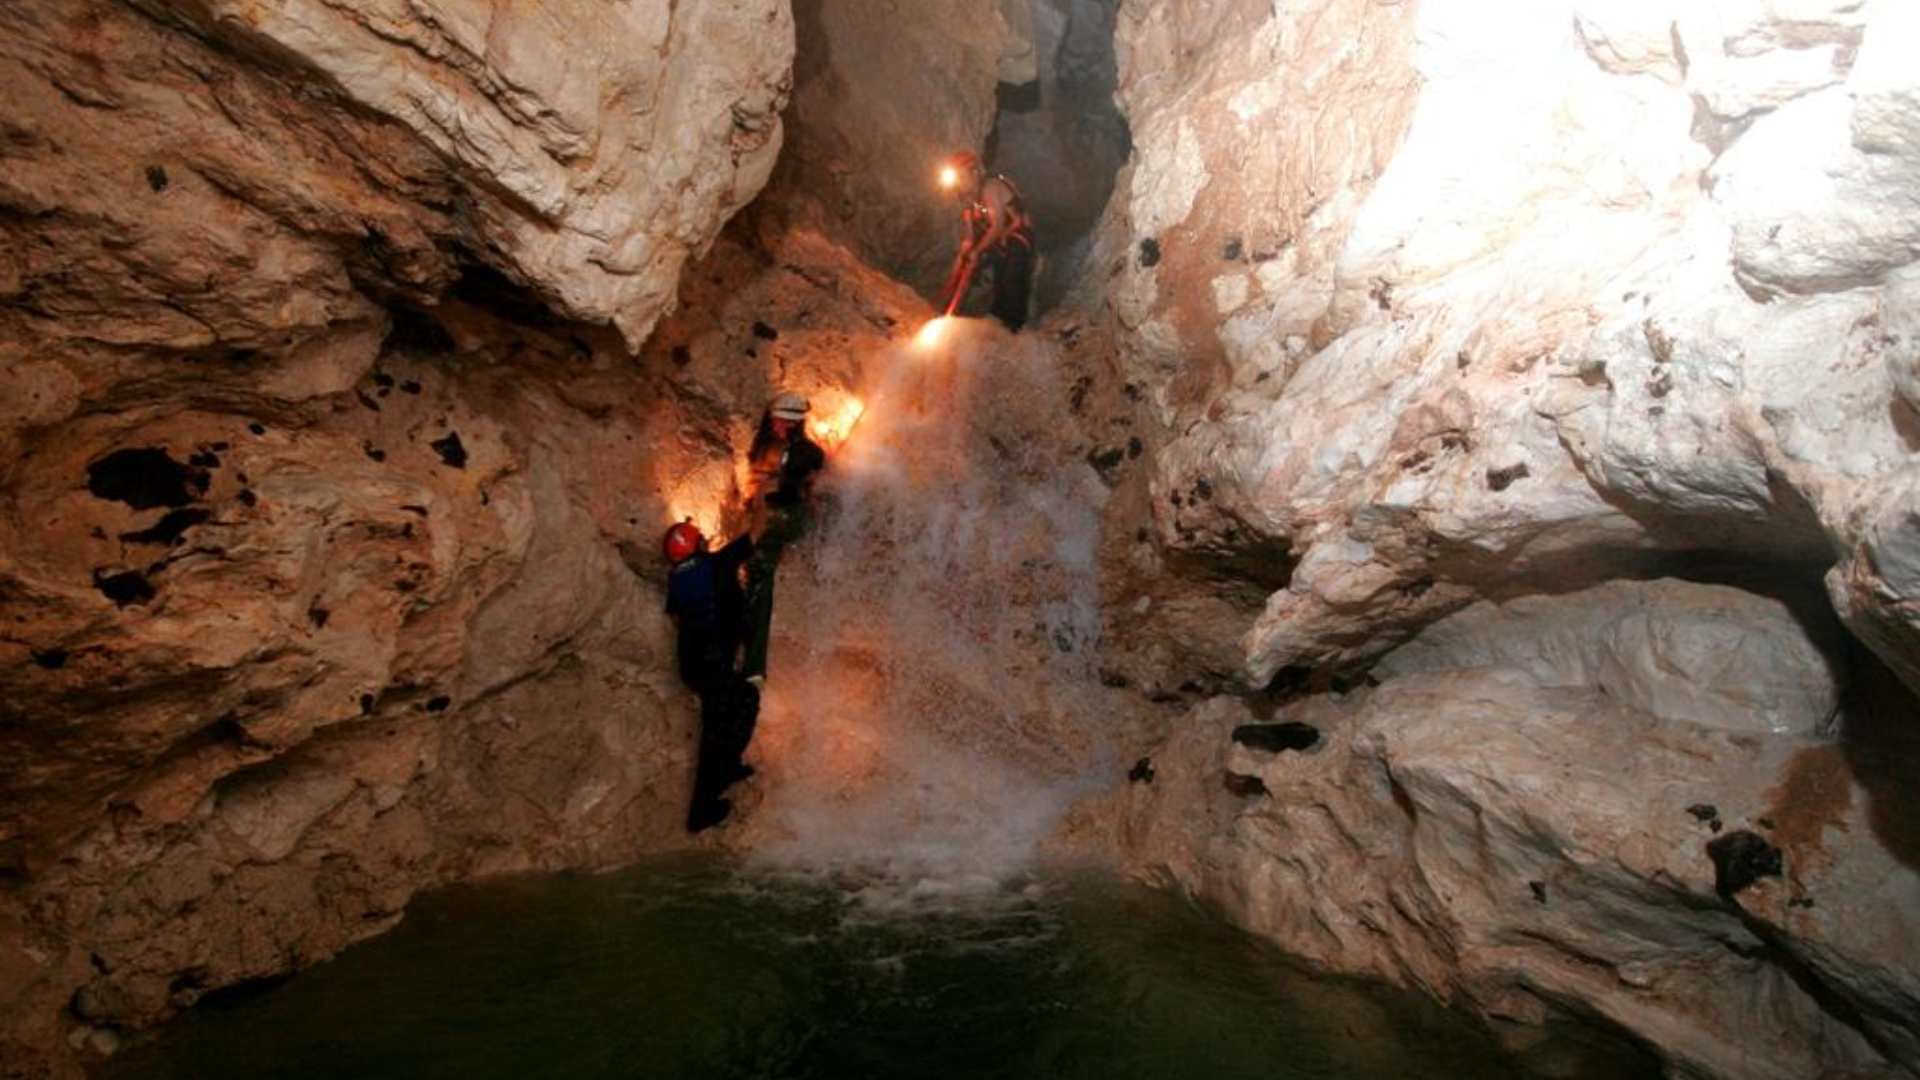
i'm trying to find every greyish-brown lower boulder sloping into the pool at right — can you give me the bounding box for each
[1073,582,1920,1080]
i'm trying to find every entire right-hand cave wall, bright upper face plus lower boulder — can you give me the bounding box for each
[1087,0,1920,1078]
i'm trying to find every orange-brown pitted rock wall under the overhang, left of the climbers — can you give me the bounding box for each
[0,205,918,1072]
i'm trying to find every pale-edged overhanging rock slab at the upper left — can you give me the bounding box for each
[0,0,793,357]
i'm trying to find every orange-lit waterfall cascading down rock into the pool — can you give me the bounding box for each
[755,321,1112,903]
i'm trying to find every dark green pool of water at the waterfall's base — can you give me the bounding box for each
[96,859,1655,1080]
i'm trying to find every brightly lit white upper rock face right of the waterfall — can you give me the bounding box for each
[1104,0,1920,686]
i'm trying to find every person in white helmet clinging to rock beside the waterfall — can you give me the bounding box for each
[741,394,828,686]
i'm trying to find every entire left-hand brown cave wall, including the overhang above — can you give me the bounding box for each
[0,0,810,1076]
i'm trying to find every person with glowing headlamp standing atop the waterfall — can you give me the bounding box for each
[941,150,1033,332]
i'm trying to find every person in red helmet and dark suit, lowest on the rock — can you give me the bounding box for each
[620,521,760,832]
